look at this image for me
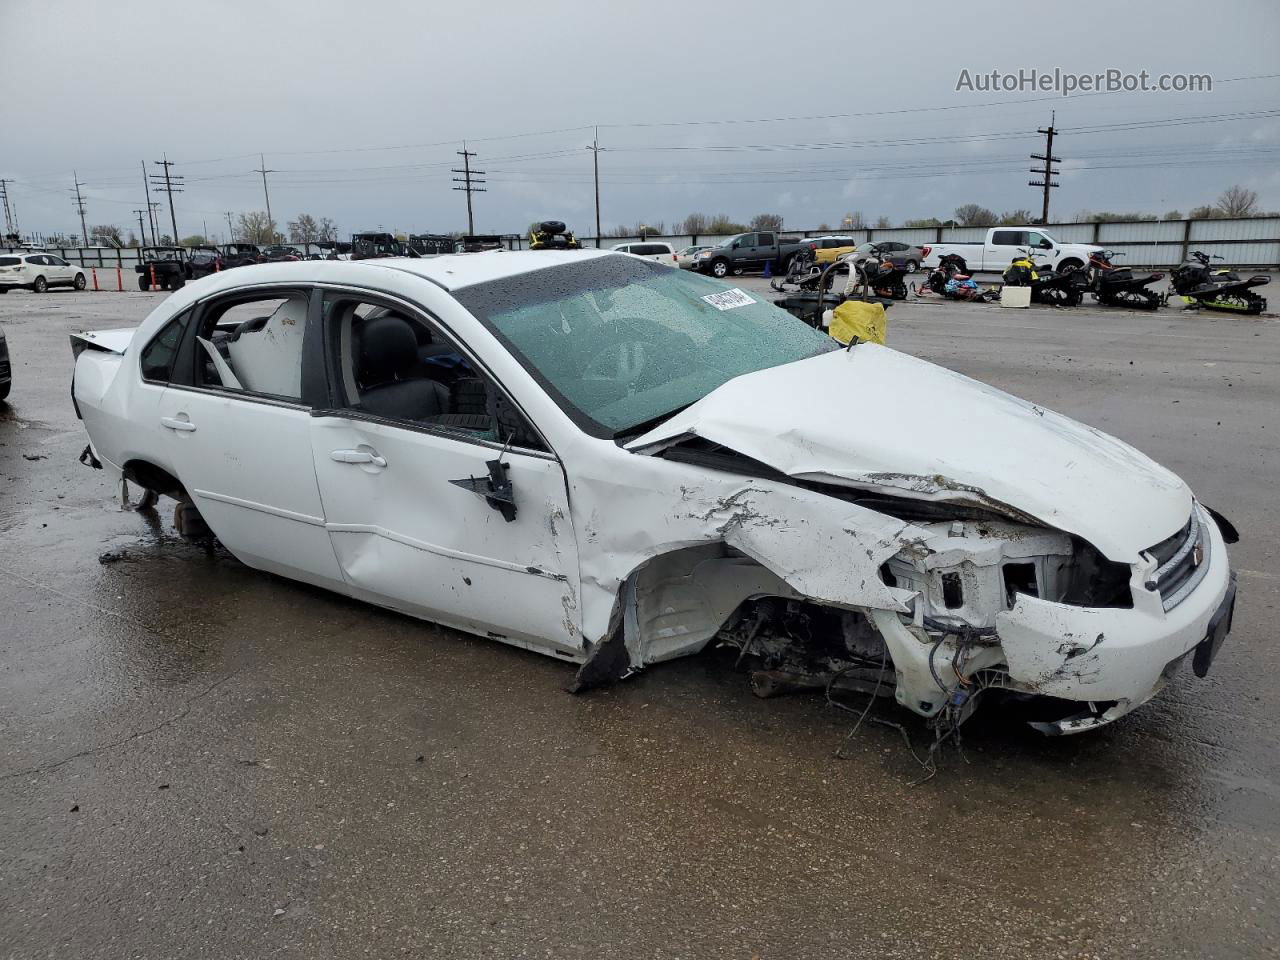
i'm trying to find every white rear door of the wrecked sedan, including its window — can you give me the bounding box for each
[155,285,344,590]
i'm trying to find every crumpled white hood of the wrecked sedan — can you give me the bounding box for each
[627,343,1192,563]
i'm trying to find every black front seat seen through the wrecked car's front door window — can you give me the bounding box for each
[356,315,449,420]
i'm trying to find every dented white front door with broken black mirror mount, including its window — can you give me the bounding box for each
[302,289,581,653]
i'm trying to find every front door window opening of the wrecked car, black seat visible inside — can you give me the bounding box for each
[324,294,545,449]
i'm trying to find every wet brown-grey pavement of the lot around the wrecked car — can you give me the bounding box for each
[0,285,1280,960]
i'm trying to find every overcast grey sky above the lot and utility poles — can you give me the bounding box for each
[0,0,1280,234]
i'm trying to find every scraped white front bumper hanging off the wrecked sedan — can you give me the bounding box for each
[996,506,1235,733]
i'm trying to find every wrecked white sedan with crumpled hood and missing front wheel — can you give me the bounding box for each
[73,251,1235,733]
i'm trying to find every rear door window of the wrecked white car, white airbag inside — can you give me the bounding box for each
[195,291,307,401]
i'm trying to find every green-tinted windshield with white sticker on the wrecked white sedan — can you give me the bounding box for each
[454,256,838,436]
